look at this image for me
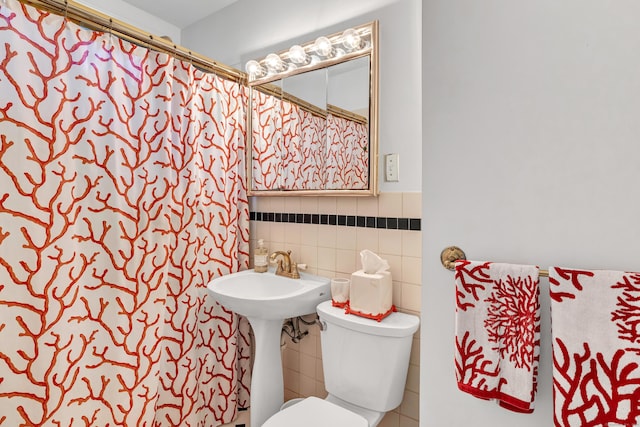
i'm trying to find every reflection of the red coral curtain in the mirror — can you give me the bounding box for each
[251,90,370,190]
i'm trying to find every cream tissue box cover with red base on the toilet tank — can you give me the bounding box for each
[346,270,395,321]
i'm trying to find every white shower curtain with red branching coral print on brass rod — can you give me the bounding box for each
[0,0,250,427]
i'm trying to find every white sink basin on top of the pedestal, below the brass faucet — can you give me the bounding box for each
[207,270,331,320]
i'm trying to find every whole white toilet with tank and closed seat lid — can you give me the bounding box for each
[263,301,420,427]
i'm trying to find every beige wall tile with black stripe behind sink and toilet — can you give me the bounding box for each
[250,193,422,427]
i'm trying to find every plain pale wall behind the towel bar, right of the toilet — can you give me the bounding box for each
[420,0,640,427]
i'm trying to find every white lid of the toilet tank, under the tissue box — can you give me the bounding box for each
[316,300,420,337]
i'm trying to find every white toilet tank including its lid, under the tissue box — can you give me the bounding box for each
[317,301,420,412]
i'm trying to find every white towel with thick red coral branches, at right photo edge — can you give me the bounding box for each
[549,267,640,427]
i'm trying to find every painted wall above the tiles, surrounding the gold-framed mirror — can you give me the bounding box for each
[182,0,422,192]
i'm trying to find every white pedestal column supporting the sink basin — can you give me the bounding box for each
[247,317,284,427]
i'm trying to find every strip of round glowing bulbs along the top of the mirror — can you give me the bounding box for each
[245,24,372,85]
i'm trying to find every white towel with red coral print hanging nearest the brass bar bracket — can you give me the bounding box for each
[455,260,540,413]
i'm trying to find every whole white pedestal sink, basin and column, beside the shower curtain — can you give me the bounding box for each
[207,270,331,427]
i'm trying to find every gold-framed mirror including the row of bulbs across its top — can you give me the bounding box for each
[247,21,378,196]
